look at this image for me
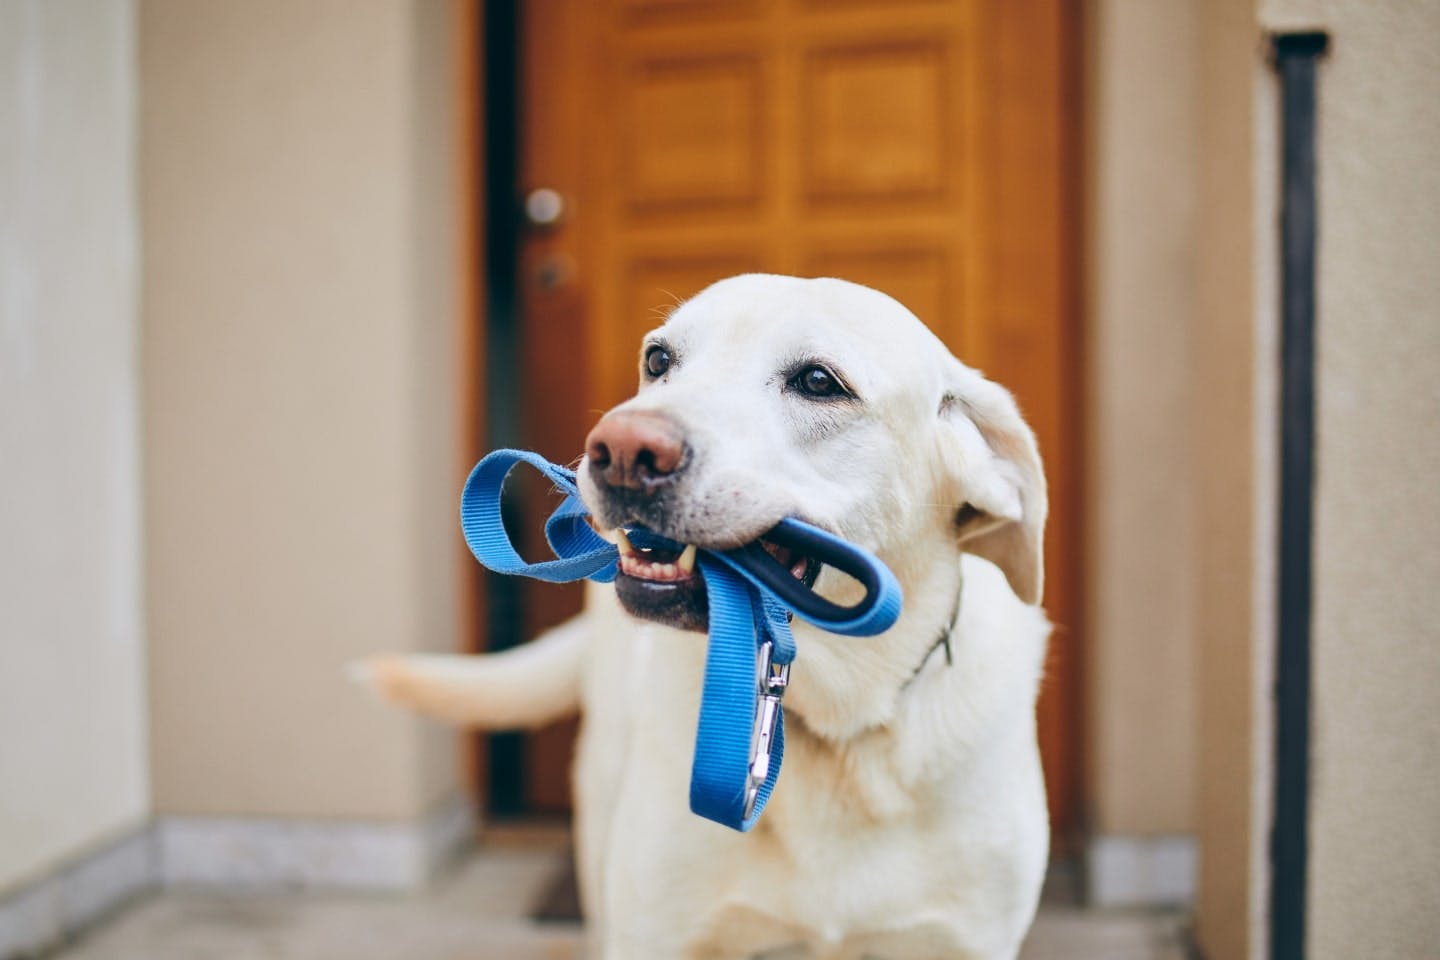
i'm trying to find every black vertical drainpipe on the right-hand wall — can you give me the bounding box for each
[1270,33,1329,960]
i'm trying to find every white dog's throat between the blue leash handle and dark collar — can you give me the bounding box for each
[785,544,963,741]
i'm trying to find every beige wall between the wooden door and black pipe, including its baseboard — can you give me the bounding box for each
[1086,0,1279,957]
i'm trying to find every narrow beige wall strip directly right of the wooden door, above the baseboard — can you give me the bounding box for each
[1086,0,1200,840]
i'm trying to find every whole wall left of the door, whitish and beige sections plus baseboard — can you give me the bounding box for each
[0,0,474,956]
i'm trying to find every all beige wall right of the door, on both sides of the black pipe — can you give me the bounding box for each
[1087,0,1440,957]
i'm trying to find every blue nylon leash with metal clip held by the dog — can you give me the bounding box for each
[459,450,901,832]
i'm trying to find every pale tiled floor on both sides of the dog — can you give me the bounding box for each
[56,838,1185,960]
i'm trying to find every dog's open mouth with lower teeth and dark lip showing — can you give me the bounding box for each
[613,530,822,633]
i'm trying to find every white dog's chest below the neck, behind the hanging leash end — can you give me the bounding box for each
[579,613,1044,960]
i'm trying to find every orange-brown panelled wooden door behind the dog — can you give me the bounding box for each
[509,0,1080,841]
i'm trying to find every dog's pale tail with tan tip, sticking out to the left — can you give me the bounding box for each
[348,613,590,730]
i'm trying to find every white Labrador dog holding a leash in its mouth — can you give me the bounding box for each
[366,275,1050,960]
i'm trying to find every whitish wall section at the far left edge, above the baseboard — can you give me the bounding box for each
[0,0,150,897]
